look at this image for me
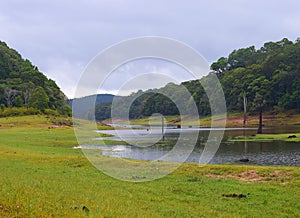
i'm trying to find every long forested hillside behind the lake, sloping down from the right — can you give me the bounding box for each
[96,38,300,120]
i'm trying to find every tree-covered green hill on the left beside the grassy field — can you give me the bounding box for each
[0,41,70,114]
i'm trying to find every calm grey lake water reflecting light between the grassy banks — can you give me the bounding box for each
[80,126,300,166]
